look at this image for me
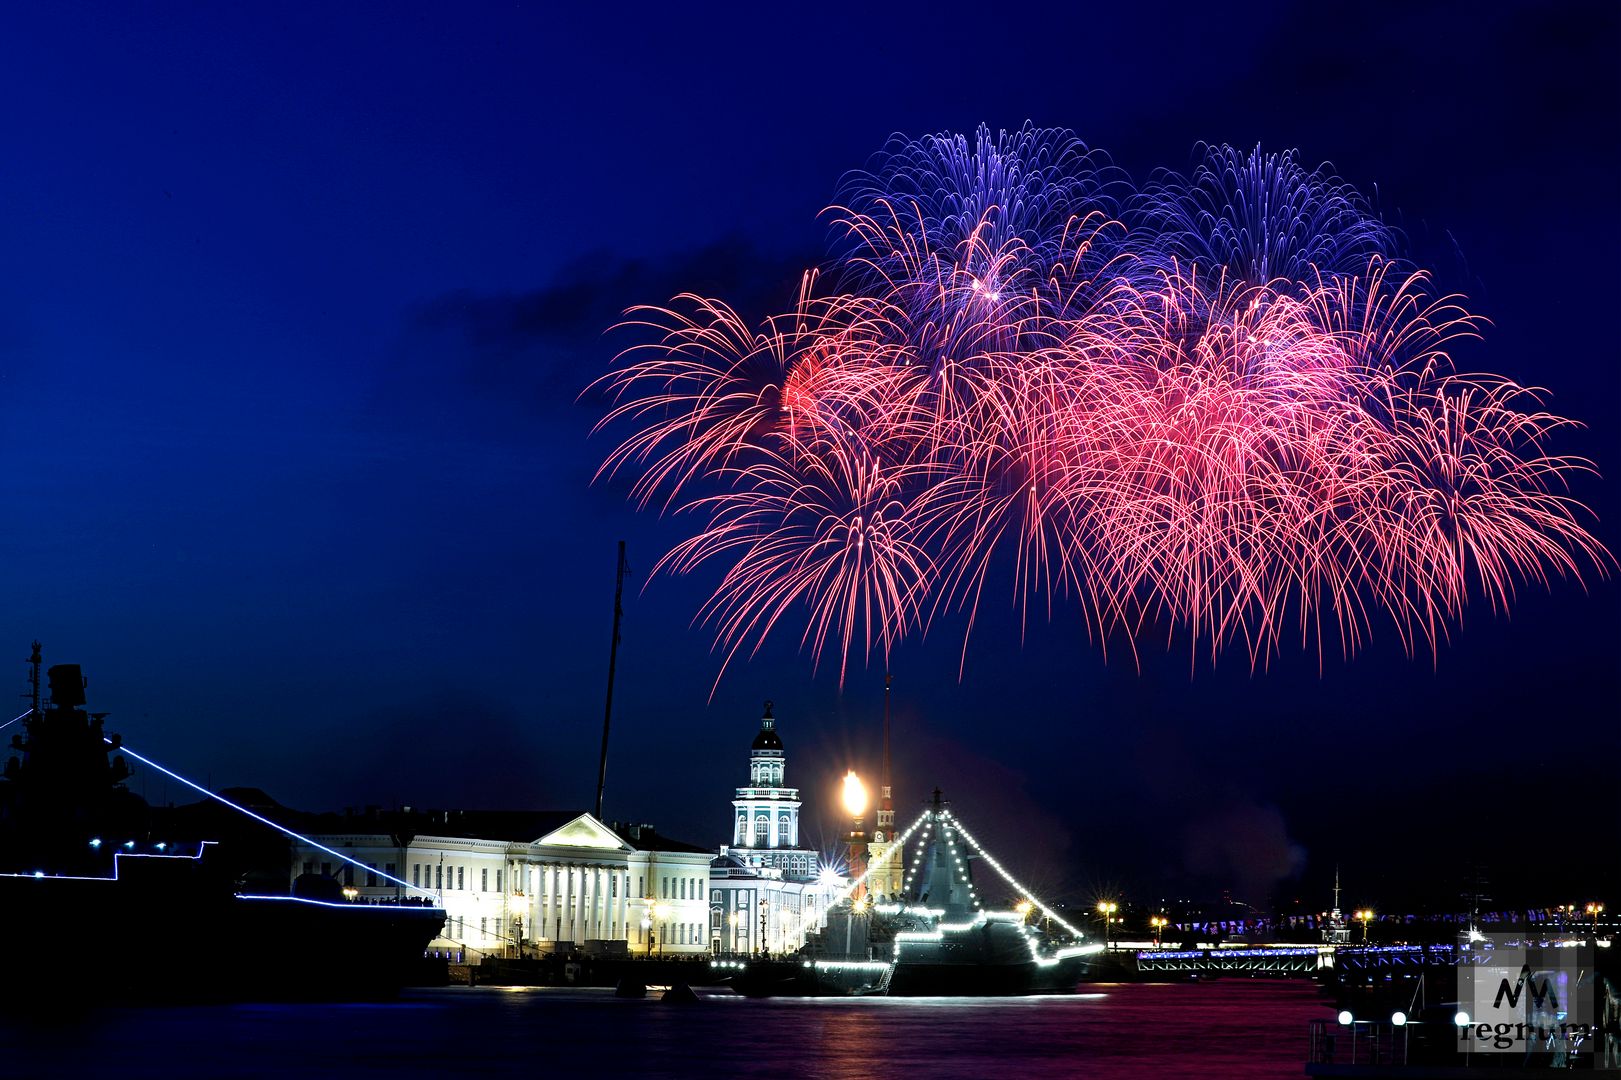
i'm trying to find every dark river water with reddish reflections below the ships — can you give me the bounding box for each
[0,978,1331,1080]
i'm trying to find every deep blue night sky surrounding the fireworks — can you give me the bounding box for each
[0,3,1621,908]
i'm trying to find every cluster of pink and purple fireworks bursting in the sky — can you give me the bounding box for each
[597,126,1611,678]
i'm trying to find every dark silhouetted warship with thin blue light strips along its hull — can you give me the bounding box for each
[0,642,444,1001]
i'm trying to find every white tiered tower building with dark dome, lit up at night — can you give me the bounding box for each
[708,702,845,954]
